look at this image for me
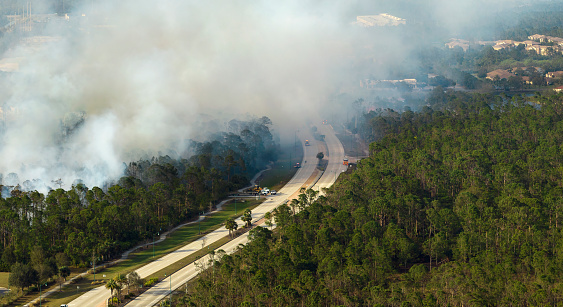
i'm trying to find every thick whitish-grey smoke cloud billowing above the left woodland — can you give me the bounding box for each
[0,0,536,188]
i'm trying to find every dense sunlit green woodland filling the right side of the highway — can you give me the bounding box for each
[178,92,563,306]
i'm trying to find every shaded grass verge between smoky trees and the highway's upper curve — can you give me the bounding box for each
[260,145,303,190]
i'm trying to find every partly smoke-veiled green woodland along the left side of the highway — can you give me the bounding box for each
[0,117,277,287]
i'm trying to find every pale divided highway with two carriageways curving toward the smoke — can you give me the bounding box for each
[69,125,346,307]
